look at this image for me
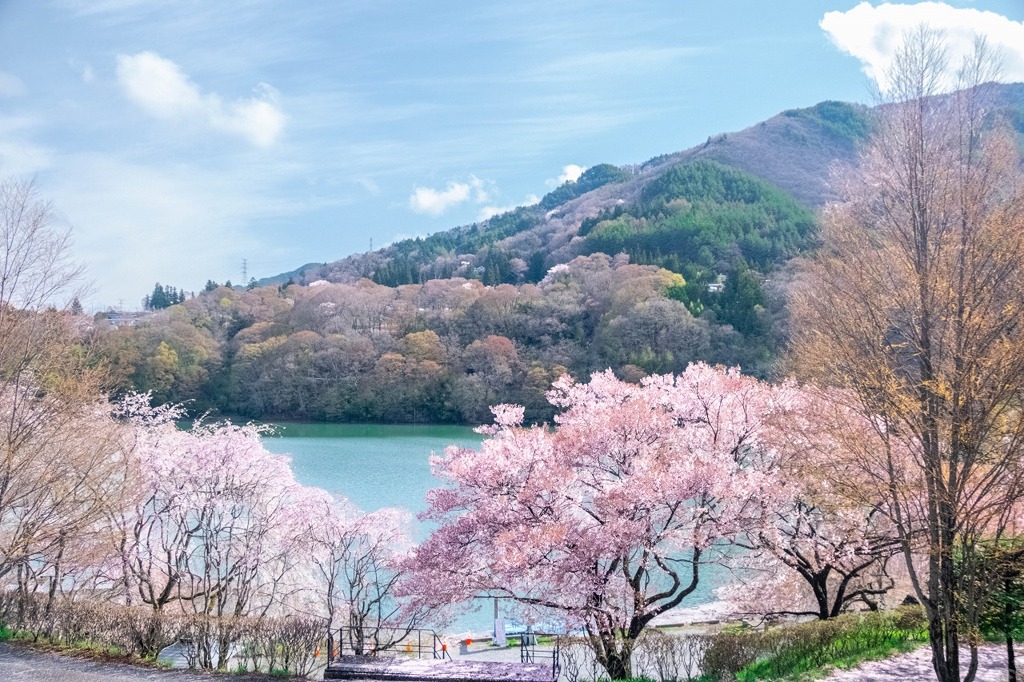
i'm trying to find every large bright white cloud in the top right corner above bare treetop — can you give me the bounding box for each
[819,2,1024,89]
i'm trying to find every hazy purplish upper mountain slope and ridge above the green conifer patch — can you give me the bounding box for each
[284,84,1024,286]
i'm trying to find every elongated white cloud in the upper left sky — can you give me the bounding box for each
[118,52,285,146]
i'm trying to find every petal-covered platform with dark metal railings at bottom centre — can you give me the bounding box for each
[324,628,560,682]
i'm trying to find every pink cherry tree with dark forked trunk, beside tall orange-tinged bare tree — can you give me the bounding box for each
[719,388,900,620]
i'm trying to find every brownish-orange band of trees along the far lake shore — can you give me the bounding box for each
[96,254,786,423]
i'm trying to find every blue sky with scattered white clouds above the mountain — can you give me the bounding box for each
[0,0,1024,310]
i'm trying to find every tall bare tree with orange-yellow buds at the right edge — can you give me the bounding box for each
[794,28,1024,682]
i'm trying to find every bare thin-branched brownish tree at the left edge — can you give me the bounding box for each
[0,179,118,600]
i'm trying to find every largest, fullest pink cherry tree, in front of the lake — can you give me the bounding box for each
[406,365,792,679]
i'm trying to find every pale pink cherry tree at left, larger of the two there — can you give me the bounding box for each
[114,396,305,668]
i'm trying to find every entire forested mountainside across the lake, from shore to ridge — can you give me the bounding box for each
[88,86,1024,423]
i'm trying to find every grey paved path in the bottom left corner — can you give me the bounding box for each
[0,642,299,682]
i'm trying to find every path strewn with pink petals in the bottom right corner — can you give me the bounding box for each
[823,645,1024,682]
